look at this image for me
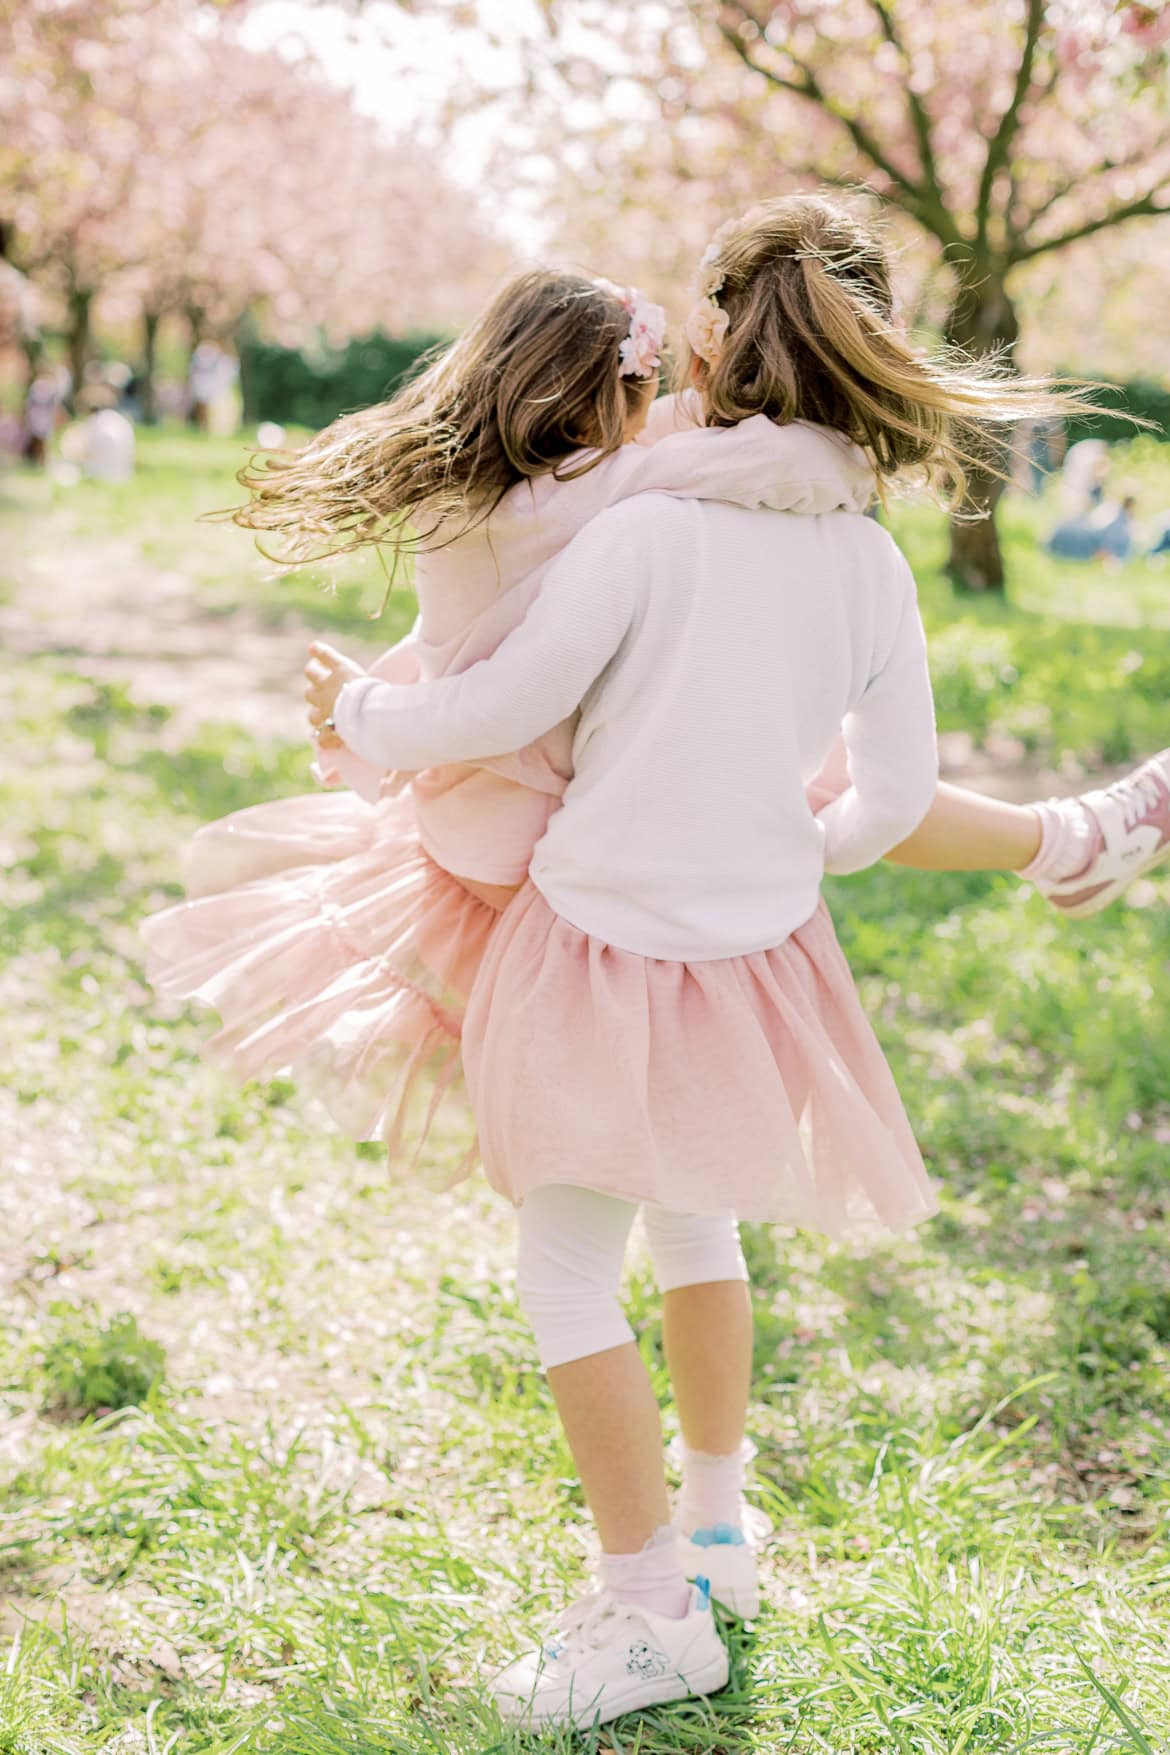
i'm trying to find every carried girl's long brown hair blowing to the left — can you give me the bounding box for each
[232,269,656,563]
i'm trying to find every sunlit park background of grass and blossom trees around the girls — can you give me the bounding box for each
[0,0,1170,1755]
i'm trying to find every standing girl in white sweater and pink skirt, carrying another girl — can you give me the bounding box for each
[299,197,1164,1723]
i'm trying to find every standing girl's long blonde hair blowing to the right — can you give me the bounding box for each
[679,195,1096,507]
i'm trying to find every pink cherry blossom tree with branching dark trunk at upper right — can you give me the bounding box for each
[391,0,1170,588]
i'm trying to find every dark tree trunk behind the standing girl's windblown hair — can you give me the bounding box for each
[945,263,1019,591]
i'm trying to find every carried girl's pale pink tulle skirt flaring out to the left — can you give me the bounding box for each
[144,792,500,1188]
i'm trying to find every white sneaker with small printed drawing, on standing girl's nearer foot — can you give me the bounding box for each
[488,1580,728,1729]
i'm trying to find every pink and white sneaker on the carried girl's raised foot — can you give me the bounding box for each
[1037,749,1170,920]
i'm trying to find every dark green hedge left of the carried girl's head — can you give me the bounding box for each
[240,330,440,428]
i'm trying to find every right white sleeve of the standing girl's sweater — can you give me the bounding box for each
[819,549,938,876]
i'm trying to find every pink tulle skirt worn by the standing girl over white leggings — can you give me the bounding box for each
[463,883,937,1237]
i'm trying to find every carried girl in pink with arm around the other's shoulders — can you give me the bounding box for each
[146,247,1170,1188]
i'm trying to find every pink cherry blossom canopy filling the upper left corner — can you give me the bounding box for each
[0,0,502,402]
